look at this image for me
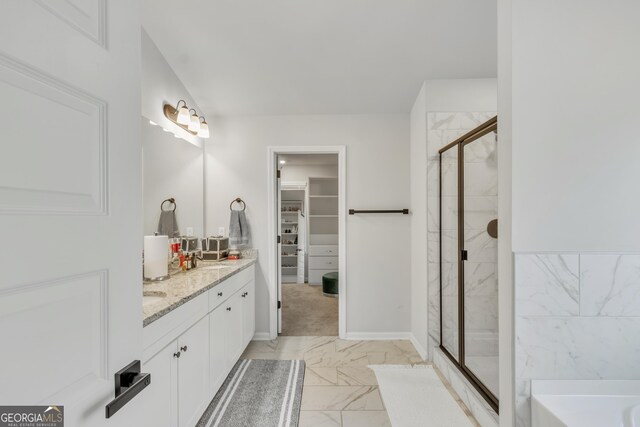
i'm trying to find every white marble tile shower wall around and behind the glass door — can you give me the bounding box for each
[427,112,498,362]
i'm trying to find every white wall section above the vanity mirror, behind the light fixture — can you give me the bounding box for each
[141,29,202,147]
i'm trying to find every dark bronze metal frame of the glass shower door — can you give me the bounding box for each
[438,116,499,413]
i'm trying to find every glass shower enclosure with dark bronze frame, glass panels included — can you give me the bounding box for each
[439,117,499,412]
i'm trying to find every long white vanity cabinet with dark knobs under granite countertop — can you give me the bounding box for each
[142,266,255,427]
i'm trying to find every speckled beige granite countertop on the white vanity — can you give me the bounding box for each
[142,253,257,326]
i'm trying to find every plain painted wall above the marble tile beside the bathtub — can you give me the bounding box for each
[512,0,640,252]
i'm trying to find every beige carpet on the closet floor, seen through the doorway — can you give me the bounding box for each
[281,283,338,336]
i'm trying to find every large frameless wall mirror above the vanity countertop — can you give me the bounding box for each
[141,117,204,237]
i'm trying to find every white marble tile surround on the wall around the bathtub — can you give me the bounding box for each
[515,253,640,427]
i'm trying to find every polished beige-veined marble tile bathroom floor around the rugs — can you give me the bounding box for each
[242,336,479,427]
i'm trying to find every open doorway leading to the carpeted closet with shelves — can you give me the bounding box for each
[271,150,345,336]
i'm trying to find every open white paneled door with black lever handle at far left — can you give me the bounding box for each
[0,0,145,427]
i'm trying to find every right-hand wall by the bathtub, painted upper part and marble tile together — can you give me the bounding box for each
[508,0,640,427]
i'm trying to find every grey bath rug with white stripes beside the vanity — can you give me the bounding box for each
[197,359,305,427]
